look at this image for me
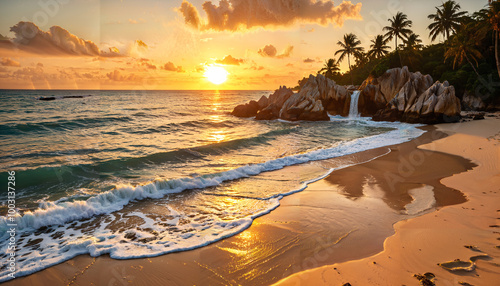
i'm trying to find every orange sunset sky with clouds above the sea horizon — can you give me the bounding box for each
[0,0,487,90]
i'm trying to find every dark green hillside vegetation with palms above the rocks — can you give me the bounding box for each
[299,0,500,104]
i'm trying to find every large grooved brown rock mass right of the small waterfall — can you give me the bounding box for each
[368,67,460,124]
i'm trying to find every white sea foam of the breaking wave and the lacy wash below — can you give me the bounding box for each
[0,122,424,282]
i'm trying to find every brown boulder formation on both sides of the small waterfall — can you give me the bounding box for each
[232,67,460,124]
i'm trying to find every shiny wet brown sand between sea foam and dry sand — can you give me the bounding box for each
[5,122,488,285]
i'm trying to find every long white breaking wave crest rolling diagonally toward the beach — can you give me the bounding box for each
[0,124,424,233]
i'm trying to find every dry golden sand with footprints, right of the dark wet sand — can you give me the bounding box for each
[274,114,500,285]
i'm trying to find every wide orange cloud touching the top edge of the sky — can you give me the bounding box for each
[177,0,362,31]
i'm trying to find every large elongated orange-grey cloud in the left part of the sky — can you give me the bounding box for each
[10,22,101,56]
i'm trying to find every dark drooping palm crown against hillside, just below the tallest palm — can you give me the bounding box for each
[444,25,482,77]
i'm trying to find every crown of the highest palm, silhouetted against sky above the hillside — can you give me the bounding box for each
[427,0,467,41]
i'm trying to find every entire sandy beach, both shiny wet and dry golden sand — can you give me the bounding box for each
[5,117,500,285]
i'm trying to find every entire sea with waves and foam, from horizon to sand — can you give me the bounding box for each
[0,90,423,282]
